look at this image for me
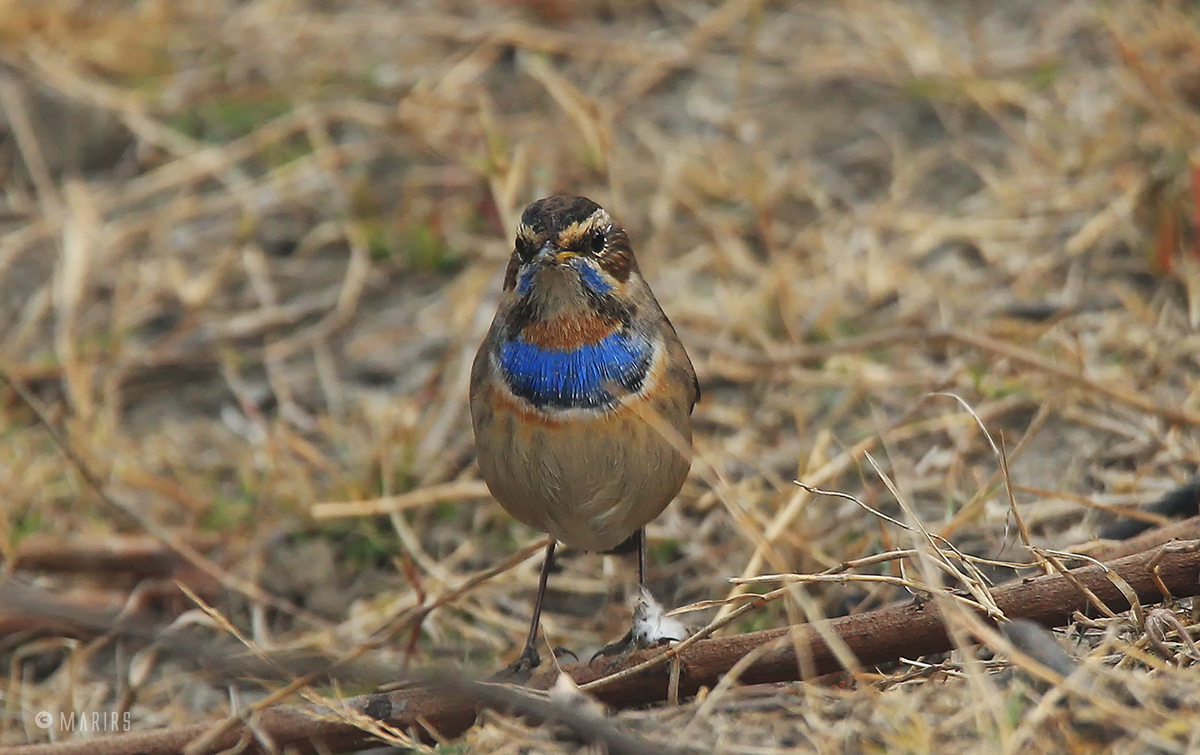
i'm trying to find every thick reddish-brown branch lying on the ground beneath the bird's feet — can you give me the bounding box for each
[11,540,1200,755]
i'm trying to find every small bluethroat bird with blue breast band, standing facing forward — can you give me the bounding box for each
[470,197,700,669]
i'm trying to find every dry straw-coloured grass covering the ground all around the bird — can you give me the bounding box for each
[7,0,1200,754]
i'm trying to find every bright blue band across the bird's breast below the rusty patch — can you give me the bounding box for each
[497,331,654,409]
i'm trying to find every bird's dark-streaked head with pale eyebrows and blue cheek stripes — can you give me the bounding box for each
[504,197,637,316]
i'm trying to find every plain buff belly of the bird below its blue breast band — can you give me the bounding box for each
[475,405,691,551]
